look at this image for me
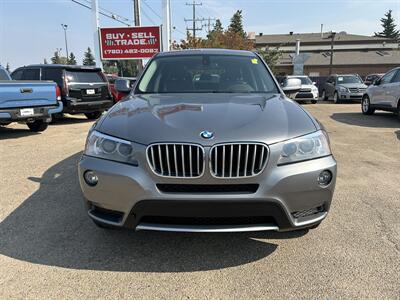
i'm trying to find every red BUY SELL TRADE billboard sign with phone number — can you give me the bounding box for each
[100,26,161,60]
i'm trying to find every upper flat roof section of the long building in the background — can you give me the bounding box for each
[255,31,395,44]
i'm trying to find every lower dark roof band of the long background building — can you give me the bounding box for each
[278,50,400,67]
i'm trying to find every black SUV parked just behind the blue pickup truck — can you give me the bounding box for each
[11,64,113,119]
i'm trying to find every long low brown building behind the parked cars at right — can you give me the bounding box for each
[252,32,400,76]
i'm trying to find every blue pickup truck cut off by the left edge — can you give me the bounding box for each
[0,66,63,132]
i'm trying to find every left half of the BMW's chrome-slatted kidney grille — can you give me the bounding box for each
[147,143,204,178]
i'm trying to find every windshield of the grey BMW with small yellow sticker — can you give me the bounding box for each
[136,54,278,94]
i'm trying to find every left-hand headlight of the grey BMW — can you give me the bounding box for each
[85,130,138,166]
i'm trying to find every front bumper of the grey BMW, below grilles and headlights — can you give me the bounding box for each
[78,146,336,232]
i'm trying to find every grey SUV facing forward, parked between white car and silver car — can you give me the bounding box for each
[321,74,367,103]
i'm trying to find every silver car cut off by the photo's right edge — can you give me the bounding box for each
[361,67,400,119]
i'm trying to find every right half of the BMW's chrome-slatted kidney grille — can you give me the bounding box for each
[210,143,268,178]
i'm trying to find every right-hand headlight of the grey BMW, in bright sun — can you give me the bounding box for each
[278,130,331,165]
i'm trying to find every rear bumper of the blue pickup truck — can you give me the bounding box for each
[0,101,63,122]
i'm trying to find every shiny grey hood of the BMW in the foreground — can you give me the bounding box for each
[96,93,317,146]
